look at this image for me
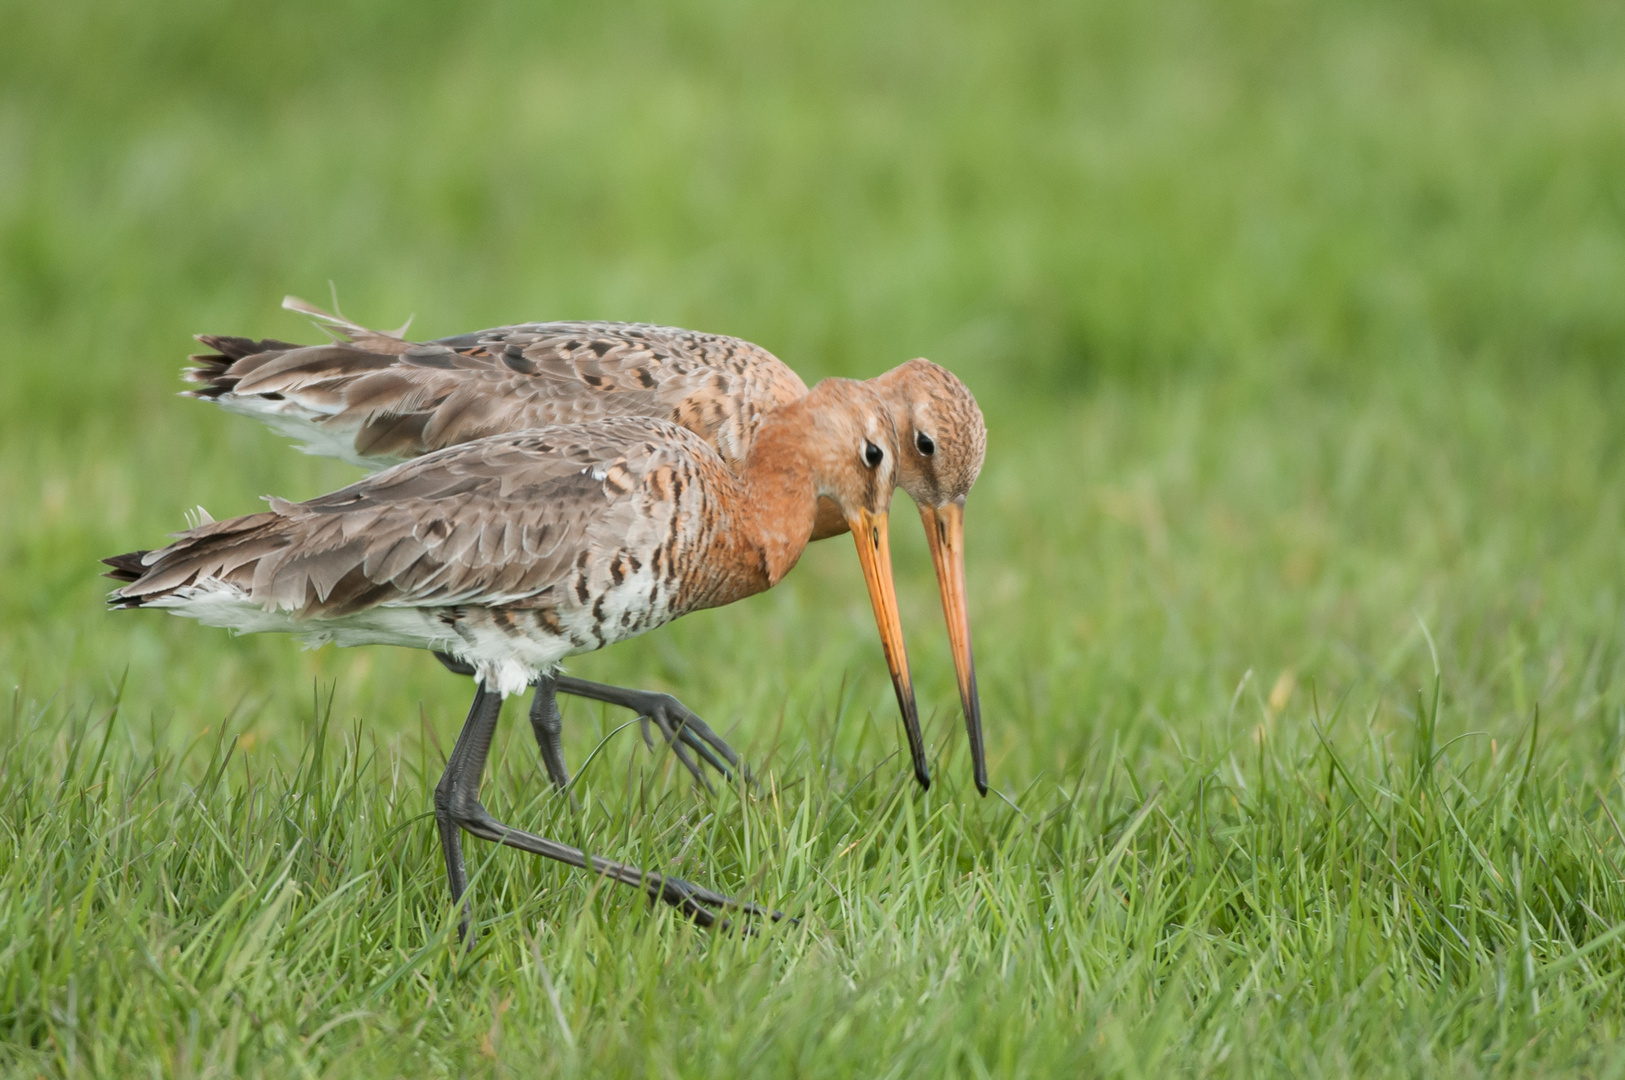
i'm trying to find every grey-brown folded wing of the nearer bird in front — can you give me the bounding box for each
[114,419,715,617]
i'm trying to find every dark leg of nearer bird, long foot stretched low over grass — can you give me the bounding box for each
[434,684,783,939]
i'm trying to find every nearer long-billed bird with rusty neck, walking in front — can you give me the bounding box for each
[106,378,913,931]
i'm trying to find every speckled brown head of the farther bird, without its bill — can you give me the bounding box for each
[873,359,988,507]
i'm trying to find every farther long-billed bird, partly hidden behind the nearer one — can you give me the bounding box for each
[187,297,988,794]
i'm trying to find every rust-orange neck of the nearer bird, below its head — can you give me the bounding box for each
[739,401,817,588]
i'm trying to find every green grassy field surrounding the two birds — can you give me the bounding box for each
[0,0,1625,1077]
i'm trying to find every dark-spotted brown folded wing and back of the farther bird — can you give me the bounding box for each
[187,309,806,468]
